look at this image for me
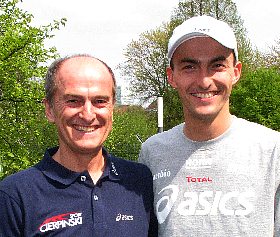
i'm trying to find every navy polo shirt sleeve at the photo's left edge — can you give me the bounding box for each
[0,190,22,237]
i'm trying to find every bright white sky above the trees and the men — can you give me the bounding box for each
[18,0,280,90]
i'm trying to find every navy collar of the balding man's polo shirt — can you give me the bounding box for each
[35,147,121,185]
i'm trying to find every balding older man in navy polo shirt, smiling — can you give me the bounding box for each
[0,55,157,237]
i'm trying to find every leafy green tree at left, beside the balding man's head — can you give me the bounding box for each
[0,0,66,178]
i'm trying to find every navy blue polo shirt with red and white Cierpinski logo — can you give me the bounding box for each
[0,148,157,237]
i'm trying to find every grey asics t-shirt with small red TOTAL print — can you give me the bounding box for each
[139,116,280,237]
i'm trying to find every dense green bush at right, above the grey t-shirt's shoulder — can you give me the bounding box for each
[230,68,280,131]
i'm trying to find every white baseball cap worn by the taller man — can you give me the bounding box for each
[167,15,238,62]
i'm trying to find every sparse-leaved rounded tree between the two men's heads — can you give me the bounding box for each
[117,24,171,101]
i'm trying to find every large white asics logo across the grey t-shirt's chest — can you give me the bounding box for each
[156,185,255,224]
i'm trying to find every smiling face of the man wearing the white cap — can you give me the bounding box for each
[167,37,241,138]
